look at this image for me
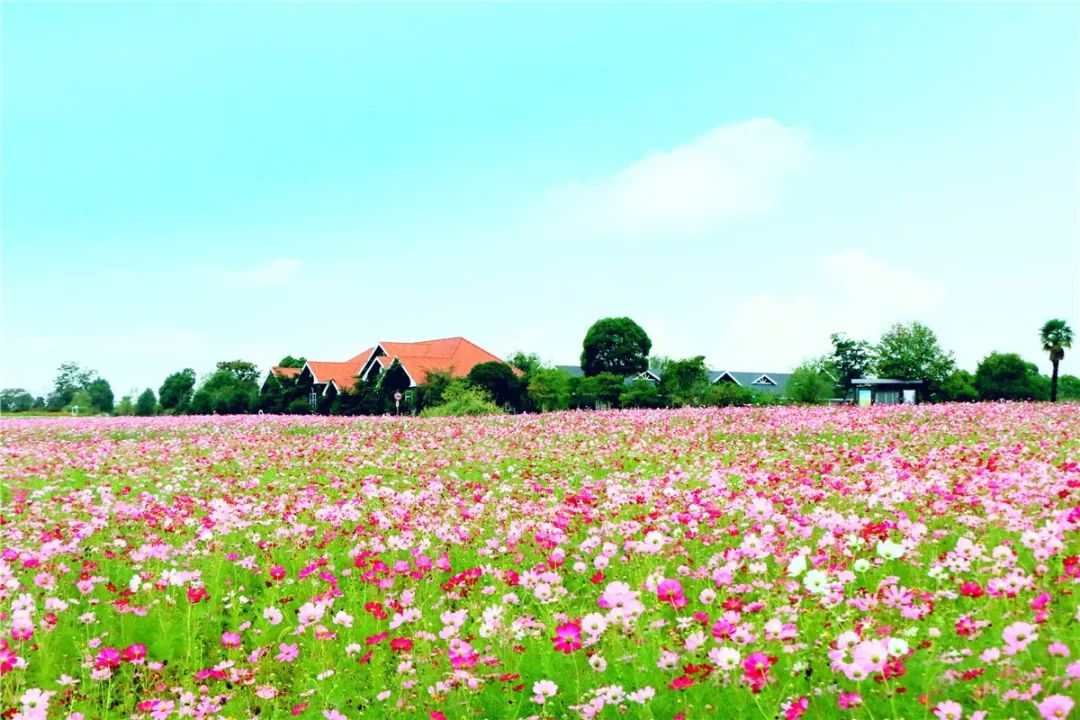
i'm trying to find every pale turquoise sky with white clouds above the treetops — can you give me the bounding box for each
[0,2,1080,397]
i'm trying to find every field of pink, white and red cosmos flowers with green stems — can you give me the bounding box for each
[0,404,1080,720]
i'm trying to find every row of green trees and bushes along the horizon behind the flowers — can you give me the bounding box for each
[0,317,1080,417]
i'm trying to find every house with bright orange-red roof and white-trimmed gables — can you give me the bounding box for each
[272,337,516,405]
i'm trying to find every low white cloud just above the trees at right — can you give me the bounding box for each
[708,249,944,371]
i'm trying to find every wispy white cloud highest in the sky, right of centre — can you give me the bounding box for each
[543,119,808,240]
